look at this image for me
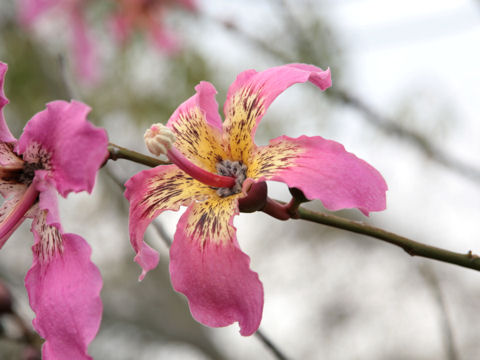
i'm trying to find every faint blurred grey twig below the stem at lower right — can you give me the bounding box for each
[419,264,460,360]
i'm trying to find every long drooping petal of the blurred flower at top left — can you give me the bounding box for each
[70,6,99,84]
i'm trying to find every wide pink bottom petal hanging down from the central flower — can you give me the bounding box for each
[170,197,263,336]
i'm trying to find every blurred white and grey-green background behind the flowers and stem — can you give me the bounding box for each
[0,0,480,360]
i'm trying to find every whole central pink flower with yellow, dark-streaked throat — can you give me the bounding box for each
[125,64,387,335]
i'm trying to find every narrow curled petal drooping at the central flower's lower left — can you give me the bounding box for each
[125,165,214,280]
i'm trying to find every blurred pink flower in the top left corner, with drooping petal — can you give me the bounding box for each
[19,0,99,84]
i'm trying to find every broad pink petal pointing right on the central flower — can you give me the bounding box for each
[248,136,388,215]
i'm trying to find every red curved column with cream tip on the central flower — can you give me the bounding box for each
[144,124,235,188]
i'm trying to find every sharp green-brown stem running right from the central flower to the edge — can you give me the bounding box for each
[298,207,480,271]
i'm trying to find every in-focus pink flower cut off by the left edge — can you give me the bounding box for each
[0,62,108,359]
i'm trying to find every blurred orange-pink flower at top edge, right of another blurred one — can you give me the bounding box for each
[112,0,195,53]
